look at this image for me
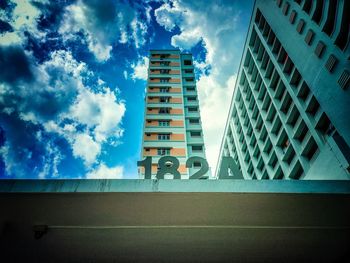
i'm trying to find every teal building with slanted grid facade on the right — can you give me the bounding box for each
[218,0,350,179]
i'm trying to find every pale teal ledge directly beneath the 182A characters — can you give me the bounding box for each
[0,179,350,194]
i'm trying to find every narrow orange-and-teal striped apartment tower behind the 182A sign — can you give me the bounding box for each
[139,50,205,179]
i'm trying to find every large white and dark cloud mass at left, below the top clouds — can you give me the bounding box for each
[0,46,126,178]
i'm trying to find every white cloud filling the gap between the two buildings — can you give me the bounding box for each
[155,0,245,171]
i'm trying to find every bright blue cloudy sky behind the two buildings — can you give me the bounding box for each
[0,0,253,179]
